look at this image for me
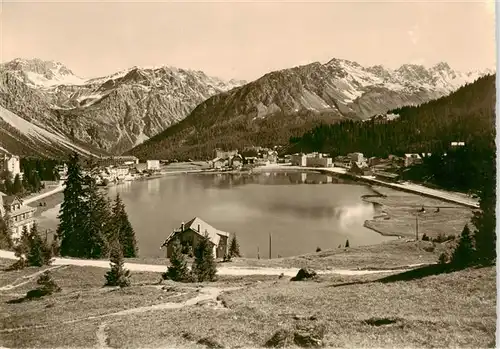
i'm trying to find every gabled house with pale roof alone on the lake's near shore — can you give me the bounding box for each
[162,217,229,258]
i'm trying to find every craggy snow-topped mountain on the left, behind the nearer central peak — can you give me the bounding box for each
[0,59,242,153]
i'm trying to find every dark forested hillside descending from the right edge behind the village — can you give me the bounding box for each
[288,75,496,156]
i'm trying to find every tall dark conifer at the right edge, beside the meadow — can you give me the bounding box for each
[472,151,496,265]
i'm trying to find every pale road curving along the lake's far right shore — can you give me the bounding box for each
[253,164,479,208]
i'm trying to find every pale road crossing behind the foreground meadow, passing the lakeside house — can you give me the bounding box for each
[0,250,418,277]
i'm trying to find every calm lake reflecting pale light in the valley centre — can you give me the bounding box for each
[35,172,393,258]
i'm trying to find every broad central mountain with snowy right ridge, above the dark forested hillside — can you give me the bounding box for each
[128,59,492,159]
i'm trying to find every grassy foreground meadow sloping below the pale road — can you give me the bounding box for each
[0,258,496,348]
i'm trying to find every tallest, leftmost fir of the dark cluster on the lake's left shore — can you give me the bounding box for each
[57,153,87,257]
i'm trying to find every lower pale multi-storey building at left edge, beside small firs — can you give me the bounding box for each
[0,192,36,240]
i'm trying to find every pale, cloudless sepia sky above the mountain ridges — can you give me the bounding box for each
[0,0,496,80]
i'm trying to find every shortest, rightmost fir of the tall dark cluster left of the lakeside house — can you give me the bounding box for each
[111,194,139,258]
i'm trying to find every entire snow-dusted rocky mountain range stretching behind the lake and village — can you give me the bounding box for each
[0,59,490,158]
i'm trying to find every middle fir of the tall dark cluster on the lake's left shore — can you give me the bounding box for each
[81,179,109,258]
